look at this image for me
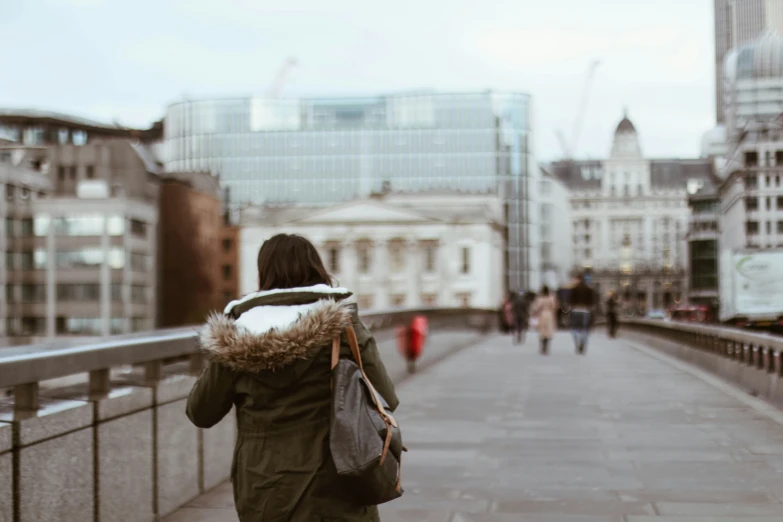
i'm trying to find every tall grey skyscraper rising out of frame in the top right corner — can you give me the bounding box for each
[715,0,783,123]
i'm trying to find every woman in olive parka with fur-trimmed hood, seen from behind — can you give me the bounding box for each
[187,234,398,522]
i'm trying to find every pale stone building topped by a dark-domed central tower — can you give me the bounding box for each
[548,111,714,314]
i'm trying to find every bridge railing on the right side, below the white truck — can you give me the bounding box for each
[621,319,783,407]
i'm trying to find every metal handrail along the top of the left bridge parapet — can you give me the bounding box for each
[0,308,497,388]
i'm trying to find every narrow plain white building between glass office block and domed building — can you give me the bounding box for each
[531,169,574,291]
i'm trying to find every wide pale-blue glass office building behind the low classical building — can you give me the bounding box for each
[164,91,538,289]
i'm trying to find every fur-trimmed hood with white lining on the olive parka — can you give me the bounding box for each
[200,285,356,373]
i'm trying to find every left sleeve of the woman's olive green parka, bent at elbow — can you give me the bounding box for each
[187,363,234,428]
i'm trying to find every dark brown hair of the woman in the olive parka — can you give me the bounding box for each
[258,234,332,291]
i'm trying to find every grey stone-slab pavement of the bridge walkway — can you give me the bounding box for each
[166,332,783,522]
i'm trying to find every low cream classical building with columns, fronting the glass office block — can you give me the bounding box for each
[239,192,505,309]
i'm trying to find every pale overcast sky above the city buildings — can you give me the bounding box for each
[0,0,715,160]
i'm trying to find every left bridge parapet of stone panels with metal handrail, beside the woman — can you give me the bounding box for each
[0,308,497,522]
